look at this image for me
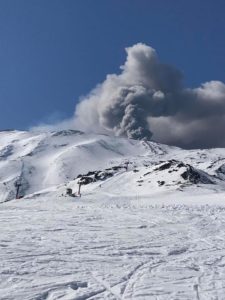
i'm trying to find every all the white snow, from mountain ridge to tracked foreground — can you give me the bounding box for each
[0,131,225,300]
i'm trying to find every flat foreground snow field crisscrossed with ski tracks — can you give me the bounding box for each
[0,197,225,300]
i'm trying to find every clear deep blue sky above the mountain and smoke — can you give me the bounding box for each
[0,0,225,129]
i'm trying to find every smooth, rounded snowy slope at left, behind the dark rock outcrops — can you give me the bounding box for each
[0,131,153,201]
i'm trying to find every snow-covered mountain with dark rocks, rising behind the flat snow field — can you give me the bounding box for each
[0,130,225,202]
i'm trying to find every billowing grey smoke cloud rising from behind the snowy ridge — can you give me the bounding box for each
[74,43,225,148]
